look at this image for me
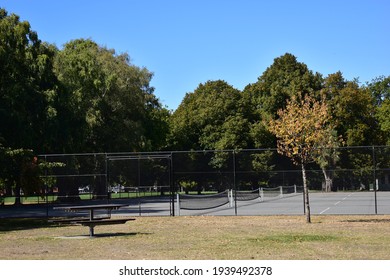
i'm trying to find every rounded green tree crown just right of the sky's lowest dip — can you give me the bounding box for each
[170,80,250,150]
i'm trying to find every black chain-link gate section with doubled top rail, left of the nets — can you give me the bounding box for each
[107,153,175,216]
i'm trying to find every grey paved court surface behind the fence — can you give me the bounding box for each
[0,192,390,218]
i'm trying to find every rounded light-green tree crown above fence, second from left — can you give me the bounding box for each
[55,39,169,152]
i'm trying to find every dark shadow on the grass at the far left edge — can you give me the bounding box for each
[0,218,57,232]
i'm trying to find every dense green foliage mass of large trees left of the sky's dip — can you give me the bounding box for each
[0,9,170,200]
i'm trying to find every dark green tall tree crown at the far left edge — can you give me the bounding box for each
[0,9,55,152]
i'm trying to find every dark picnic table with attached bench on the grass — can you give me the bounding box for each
[53,204,135,237]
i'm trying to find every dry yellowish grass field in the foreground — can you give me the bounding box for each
[0,216,390,260]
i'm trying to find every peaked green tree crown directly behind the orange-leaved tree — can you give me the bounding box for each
[243,53,323,155]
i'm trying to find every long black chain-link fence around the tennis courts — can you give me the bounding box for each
[0,146,390,215]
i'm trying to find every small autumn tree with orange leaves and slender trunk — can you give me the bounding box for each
[269,95,337,223]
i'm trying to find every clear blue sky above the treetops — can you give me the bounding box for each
[0,0,390,110]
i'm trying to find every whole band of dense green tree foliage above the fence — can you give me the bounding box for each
[0,9,390,199]
